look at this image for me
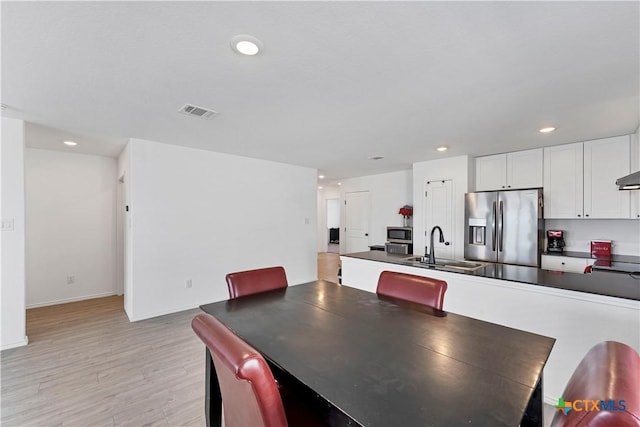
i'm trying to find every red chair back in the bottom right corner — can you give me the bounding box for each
[551,341,640,427]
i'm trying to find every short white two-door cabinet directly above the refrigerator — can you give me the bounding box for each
[476,148,543,191]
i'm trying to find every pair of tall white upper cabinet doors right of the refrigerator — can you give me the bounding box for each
[544,136,631,219]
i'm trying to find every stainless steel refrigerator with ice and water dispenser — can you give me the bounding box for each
[464,188,544,267]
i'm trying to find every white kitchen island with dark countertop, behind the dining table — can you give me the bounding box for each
[340,251,640,404]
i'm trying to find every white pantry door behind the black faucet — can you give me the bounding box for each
[425,179,455,259]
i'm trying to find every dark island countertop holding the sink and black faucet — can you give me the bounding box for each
[342,251,640,301]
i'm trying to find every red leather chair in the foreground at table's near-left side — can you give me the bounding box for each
[191,314,287,427]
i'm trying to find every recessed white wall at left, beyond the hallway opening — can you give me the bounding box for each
[25,148,117,307]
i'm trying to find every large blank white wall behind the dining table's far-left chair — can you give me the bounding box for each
[128,139,317,320]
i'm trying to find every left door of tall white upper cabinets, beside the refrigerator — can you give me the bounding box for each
[543,142,583,218]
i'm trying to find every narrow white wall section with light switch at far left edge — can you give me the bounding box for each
[0,117,28,350]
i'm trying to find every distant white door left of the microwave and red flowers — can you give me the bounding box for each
[344,191,371,253]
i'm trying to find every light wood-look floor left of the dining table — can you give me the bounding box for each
[0,296,205,427]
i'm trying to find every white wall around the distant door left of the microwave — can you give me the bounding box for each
[340,170,415,253]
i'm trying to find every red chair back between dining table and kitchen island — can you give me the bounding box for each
[376,271,447,310]
